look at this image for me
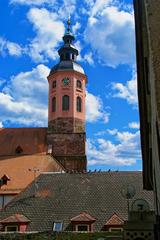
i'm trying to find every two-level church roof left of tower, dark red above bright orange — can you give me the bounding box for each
[0,128,64,194]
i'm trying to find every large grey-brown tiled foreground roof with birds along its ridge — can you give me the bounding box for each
[0,172,153,231]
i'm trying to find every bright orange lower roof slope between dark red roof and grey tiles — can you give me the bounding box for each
[0,153,63,194]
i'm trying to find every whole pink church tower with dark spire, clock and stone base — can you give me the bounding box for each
[47,20,87,171]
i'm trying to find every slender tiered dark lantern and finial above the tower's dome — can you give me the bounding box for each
[58,19,78,61]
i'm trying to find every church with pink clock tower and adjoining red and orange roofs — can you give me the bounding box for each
[0,20,87,208]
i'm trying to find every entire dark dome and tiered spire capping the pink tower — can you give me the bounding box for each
[50,19,85,75]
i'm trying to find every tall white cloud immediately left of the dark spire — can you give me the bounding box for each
[27,8,64,62]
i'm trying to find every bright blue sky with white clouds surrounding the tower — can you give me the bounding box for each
[0,0,141,170]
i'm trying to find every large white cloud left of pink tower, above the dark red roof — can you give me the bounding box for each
[0,64,49,126]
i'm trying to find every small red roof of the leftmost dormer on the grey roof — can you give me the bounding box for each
[0,213,30,223]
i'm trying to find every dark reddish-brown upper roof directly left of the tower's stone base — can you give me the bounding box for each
[0,128,47,156]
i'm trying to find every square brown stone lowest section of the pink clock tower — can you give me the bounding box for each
[47,133,87,172]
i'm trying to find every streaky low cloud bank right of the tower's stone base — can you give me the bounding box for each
[87,130,141,166]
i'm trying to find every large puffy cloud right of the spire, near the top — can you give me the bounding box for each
[84,5,135,67]
